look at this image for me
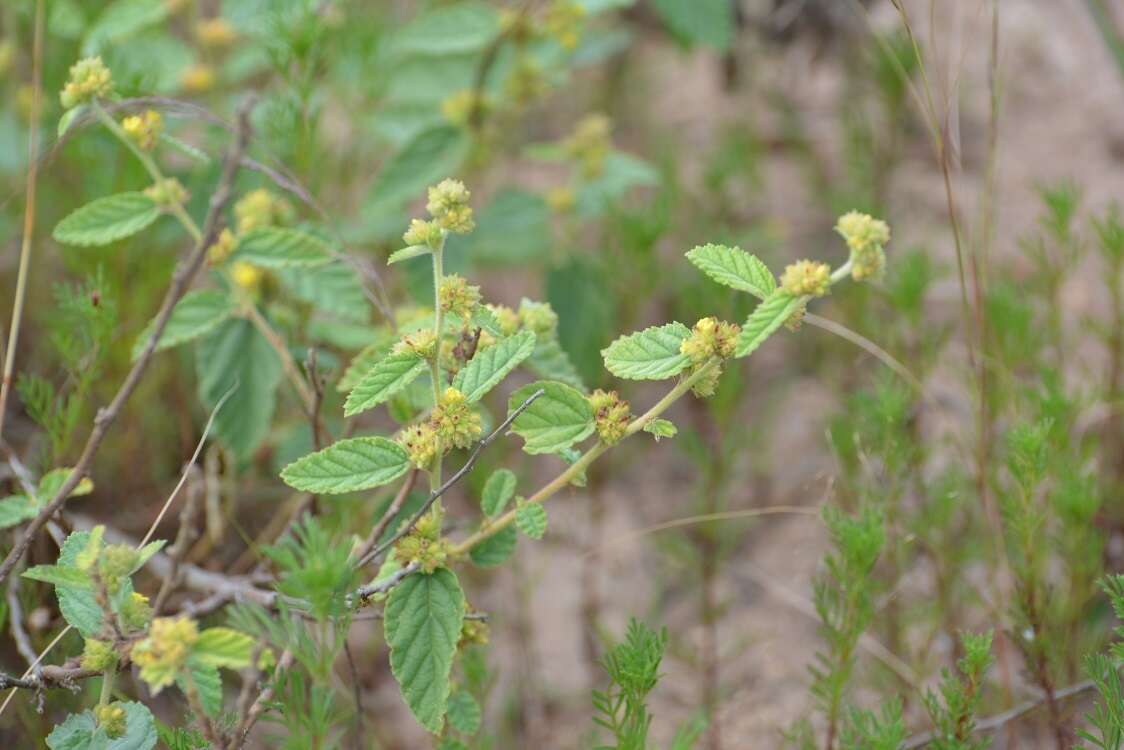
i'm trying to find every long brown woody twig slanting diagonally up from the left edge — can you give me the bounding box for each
[0,100,253,581]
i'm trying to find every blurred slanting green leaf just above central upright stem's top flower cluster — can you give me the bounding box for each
[370,125,469,205]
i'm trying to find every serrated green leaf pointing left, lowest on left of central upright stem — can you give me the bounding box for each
[281,437,410,495]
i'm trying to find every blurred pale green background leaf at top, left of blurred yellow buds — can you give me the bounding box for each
[391,2,499,55]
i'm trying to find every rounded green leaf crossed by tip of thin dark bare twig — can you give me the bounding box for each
[508,380,593,453]
